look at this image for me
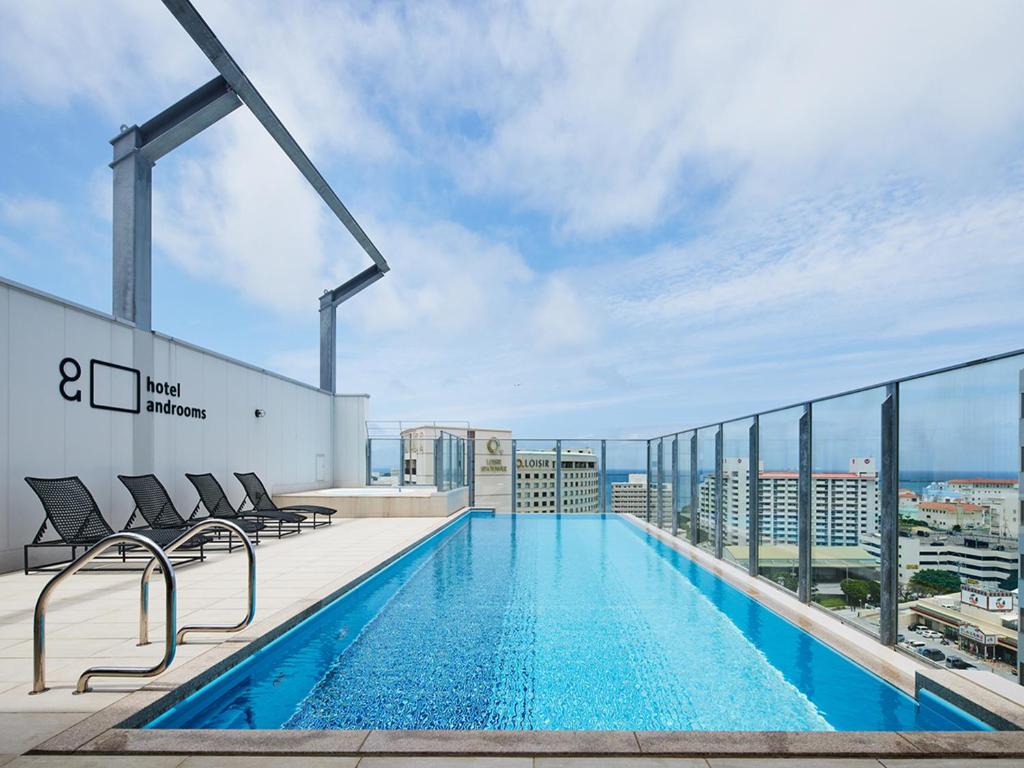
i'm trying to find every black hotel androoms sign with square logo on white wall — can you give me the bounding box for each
[57,357,206,420]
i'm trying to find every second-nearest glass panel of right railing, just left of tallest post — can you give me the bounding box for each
[810,387,886,635]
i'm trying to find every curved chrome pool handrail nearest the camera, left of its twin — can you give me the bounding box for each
[31,532,177,693]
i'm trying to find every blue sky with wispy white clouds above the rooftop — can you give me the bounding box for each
[0,0,1024,444]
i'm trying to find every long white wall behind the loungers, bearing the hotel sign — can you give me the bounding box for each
[0,281,366,571]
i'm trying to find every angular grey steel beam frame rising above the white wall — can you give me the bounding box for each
[111,0,390,392]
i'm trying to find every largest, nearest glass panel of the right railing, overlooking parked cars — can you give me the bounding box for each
[898,355,1024,680]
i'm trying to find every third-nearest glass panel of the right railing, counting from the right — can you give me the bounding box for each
[758,408,803,592]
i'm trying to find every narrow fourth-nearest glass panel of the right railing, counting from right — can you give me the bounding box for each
[722,419,754,570]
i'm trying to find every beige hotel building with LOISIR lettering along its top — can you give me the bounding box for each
[515,449,600,514]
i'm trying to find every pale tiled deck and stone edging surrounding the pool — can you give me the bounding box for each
[0,518,1024,768]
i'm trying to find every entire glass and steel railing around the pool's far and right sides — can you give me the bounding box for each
[368,351,1024,679]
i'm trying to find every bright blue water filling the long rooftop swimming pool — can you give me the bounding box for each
[150,512,983,730]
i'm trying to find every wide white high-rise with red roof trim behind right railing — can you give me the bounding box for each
[697,458,880,547]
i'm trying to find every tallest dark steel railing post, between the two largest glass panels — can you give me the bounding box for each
[879,384,899,646]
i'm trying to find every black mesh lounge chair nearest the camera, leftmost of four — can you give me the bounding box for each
[25,477,207,573]
